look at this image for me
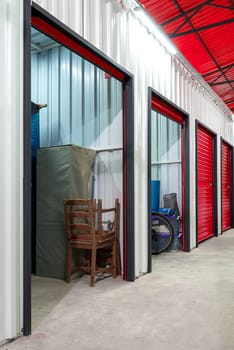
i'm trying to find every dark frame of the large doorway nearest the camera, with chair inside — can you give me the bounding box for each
[23,0,136,335]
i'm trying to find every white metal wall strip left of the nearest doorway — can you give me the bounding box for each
[0,0,23,344]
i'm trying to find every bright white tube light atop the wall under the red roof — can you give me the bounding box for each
[134,6,177,55]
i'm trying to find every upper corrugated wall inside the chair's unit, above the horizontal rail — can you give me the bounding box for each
[31,47,123,148]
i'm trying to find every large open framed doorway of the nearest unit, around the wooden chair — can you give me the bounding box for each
[24,4,135,335]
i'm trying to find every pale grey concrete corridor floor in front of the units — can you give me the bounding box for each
[3,230,234,350]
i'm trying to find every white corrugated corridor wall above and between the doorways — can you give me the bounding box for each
[33,0,233,275]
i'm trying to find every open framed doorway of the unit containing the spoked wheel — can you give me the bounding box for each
[148,89,190,271]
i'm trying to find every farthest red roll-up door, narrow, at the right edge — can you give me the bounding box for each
[222,141,232,231]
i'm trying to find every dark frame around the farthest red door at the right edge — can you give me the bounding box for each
[220,136,234,233]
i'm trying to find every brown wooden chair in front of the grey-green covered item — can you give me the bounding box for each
[64,199,120,287]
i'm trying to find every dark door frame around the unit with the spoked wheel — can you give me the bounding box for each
[147,87,190,272]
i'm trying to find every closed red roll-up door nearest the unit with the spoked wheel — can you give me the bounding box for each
[197,125,214,242]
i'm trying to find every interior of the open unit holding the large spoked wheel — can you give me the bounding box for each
[151,110,183,252]
